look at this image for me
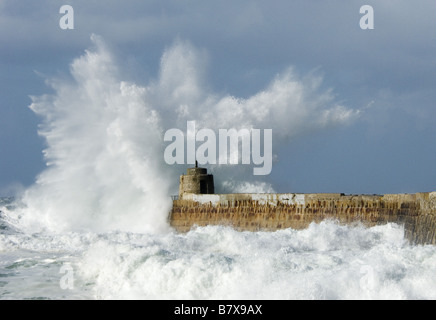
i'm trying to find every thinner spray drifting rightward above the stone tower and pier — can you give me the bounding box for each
[150,40,360,192]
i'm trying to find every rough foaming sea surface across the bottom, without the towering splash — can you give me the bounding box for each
[0,198,436,300]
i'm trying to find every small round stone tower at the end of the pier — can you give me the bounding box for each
[179,161,215,200]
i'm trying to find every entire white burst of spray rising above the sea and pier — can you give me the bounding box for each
[17,35,359,232]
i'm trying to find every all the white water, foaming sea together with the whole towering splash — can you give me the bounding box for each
[0,35,436,300]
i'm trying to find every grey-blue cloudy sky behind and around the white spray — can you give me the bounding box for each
[0,0,436,192]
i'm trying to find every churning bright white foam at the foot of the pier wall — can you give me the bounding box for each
[75,222,436,299]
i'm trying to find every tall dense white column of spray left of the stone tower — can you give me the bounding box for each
[19,37,171,232]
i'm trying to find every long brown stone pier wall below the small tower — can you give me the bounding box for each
[169,192,436,244]
